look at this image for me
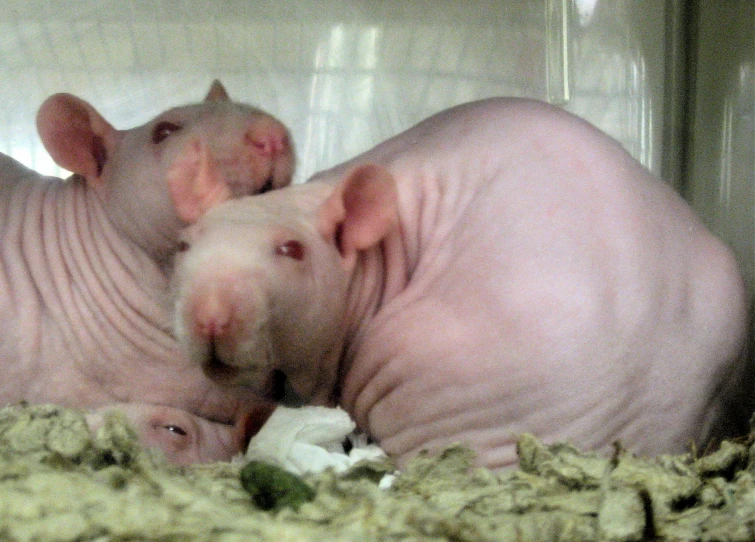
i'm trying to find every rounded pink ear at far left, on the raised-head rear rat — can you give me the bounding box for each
[37,94,120,183]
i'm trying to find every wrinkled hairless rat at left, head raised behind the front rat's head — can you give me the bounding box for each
[0,82,294,459]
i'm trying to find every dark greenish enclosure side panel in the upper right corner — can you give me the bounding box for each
[687,0,755,291]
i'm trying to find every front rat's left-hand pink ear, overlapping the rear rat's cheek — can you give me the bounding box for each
[167,141,231,224]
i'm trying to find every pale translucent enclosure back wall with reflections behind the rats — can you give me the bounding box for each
[0,0,665,181]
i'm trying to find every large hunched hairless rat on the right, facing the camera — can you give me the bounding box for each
[174,99,746,468]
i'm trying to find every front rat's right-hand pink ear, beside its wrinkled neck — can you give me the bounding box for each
[319,164,398,258]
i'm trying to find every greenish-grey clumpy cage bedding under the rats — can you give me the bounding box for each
[0,405,755,542]
